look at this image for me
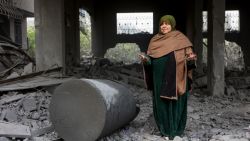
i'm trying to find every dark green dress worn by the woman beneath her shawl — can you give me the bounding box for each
[150,55,188,139]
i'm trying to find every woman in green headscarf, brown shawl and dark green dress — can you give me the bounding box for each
[140,15,196,139]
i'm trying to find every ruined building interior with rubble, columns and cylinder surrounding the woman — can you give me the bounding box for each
[0,0,250,141]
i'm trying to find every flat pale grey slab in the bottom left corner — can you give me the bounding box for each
[0,121,31,138]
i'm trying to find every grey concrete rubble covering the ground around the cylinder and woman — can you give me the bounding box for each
[0,56,250,141]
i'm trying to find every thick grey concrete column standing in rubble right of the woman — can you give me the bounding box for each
[208,0,225,96]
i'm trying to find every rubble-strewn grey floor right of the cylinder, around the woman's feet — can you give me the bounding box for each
[97,86,250,141]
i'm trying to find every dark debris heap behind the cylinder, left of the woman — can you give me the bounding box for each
[76,58,145,87]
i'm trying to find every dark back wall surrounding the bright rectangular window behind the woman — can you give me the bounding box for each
[87,0,186,57]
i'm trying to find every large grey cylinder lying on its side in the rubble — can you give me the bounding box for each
[50,79,137,141]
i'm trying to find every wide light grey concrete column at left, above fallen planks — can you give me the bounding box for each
[34,0,65,71]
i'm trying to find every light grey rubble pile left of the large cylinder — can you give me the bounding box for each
[0,91,57,141]
